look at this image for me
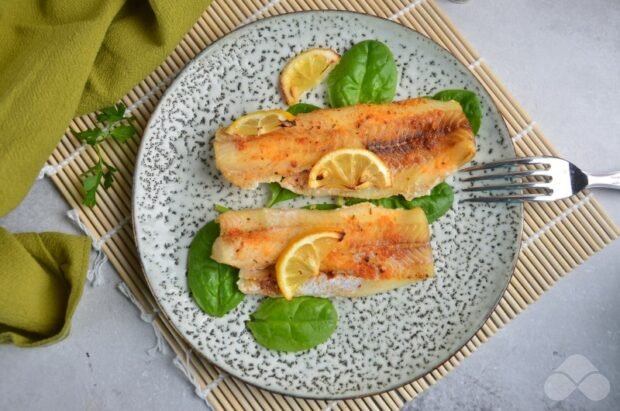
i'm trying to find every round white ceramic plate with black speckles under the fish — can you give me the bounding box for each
[133,11,522,399]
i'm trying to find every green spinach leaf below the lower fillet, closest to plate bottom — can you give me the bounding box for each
[245,297,338,352]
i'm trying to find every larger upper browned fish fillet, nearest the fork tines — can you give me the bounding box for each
[214,98,476,199]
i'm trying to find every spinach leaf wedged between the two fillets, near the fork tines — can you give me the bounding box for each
[345,183,454,224]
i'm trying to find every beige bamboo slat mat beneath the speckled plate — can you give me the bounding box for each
[43,0,620,410]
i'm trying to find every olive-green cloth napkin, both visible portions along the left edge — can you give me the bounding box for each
[0,0,209,345]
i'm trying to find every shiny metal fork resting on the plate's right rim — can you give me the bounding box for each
[461,157,620,202]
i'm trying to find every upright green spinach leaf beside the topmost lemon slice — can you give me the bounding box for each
[327,40,398,107]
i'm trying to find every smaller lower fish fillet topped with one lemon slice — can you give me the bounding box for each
[212,203,433,297]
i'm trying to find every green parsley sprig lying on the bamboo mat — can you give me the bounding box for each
[75,103,136,207]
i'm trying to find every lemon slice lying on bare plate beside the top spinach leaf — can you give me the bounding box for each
[280,48,340,105]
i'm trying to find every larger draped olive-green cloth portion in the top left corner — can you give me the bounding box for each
[0,0,209,215]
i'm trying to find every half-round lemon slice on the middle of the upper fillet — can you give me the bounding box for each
[308,148,392,190]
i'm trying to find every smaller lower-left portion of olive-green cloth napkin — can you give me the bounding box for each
[0,227,90,346]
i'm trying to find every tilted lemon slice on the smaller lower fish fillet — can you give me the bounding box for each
[276,231,343,300]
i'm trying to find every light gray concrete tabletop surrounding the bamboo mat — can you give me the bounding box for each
[0,0,620,410]
